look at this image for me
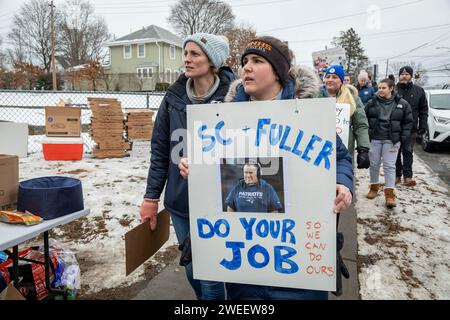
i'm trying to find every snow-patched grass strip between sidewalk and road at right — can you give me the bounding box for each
[355,156,450,299]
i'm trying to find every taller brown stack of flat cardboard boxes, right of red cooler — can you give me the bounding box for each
[88,98,131,159]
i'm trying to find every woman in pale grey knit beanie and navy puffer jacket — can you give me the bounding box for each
[140,33,235,300]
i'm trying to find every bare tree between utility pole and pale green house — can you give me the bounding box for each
[58,0,110,67]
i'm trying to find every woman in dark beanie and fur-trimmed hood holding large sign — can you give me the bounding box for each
[179,36,353,300]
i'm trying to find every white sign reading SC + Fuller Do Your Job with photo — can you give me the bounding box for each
[187,98,336,291]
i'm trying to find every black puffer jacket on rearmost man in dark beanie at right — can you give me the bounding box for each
[397,82,428,133]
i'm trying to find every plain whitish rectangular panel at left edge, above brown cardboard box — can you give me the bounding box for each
[0,121,28,158]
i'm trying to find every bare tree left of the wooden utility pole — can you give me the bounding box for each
[8,0,51,72]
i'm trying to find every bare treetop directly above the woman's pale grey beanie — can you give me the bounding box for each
[167,0,235,38]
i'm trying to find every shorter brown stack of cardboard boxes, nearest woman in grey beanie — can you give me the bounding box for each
[125,109,153,140]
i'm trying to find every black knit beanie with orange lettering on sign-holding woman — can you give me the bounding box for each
[241,37,291,87]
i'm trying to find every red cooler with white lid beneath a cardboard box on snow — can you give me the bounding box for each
[42,137,83,160]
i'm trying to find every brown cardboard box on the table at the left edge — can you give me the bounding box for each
[0,154,19,206]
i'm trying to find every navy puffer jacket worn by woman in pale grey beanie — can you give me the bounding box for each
[144,67,236,217]
